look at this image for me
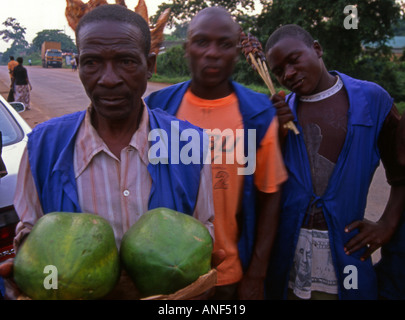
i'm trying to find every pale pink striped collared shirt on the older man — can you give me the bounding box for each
[14,104,214,248]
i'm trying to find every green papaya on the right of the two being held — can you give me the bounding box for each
[120,208,213,297]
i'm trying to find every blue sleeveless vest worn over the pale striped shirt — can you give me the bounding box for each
[28,108,205,215]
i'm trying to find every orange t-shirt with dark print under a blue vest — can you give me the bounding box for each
[176,90,287,285]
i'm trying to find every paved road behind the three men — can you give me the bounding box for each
[0,66,389,261]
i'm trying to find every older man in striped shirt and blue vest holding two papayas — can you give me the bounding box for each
[0,5,219,299]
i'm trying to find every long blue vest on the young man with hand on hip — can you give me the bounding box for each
[267,72,393,299]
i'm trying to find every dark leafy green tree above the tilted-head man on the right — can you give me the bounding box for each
[255,0,400,72]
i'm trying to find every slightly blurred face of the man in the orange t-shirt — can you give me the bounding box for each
[186,15,239,89]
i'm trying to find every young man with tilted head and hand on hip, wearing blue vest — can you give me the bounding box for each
[266,25,405,299]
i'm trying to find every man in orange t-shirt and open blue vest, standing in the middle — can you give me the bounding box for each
[146,7,287,299]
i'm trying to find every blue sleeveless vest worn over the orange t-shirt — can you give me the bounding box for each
[145,81,275,269]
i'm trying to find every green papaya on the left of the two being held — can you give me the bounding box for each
[14,212,120,300]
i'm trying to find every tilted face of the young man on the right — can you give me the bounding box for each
[266,37,324,95]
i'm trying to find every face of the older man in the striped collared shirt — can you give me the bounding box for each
[78,21,155,120]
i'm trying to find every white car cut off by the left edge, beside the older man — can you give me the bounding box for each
[0,95,31,299]
